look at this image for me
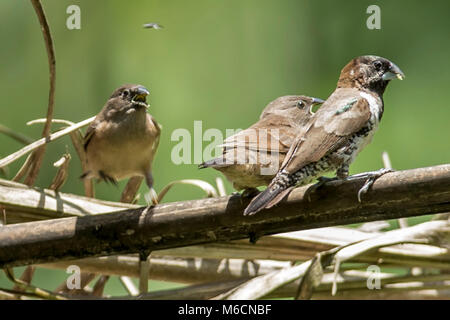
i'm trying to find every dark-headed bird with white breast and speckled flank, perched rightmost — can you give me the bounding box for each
[244,56,404,215]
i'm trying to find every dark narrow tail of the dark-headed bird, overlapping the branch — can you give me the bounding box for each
[244,176,294,216]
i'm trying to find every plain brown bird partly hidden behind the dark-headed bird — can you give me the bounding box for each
[199,95,324,196]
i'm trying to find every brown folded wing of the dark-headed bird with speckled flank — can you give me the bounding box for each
[281,97,371,173]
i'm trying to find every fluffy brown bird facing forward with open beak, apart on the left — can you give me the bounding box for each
[81,84,161,189]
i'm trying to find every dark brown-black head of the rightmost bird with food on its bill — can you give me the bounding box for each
[338,56,405,94]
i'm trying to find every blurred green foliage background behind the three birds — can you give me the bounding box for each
[0,0,450,294]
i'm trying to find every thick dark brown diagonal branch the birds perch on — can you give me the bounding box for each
[0,165,450,267]
